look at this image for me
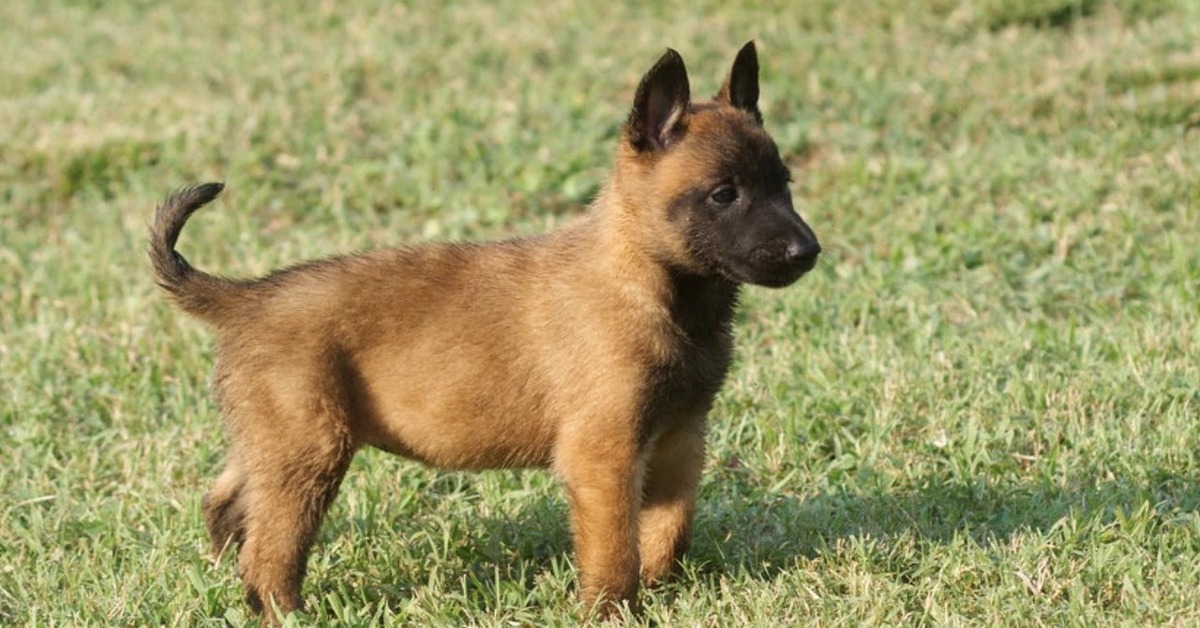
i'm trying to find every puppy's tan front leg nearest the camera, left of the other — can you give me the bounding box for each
[554,425,642,616]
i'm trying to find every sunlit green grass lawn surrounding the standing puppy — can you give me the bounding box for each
[0,0,1200,626]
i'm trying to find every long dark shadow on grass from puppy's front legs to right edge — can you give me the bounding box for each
[689,471,1200,579]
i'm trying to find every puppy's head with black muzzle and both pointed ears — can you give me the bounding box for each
[618,42,821,287]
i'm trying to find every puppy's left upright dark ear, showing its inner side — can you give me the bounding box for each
[625,48,691,152]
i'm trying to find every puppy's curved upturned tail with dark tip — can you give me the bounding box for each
[150,183,239,323]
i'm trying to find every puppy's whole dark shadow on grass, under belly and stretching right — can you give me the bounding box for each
[314,469,1200,612]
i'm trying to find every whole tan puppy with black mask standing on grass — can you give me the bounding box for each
[150,42,821,614]
